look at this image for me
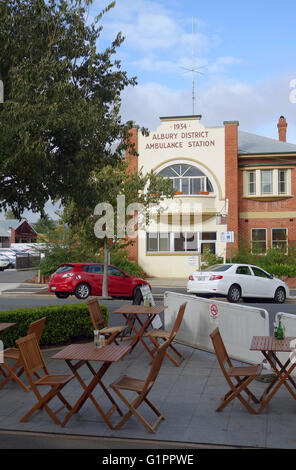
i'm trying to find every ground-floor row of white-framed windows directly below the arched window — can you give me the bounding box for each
[146,232,217,254]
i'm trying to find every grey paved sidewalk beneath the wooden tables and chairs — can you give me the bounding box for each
[0,336,296,448]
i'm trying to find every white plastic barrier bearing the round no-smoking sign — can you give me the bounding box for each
[164,292,270,364]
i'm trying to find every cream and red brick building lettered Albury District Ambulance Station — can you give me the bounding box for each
[126,116,296,277]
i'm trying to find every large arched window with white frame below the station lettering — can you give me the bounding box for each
[159,164,214,195]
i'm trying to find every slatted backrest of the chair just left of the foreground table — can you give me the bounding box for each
[16,334,48,384]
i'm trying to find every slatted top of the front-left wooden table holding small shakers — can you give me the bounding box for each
[52,343,130,362]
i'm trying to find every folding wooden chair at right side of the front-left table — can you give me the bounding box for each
[110,337,173,433]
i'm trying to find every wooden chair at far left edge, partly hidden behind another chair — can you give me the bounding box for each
[0,317,46,392]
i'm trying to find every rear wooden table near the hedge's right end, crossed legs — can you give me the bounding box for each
[113,305,167,358]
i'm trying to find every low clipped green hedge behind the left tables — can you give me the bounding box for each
[0,304,109,348]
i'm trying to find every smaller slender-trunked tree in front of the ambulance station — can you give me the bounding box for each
[66,160,175,298]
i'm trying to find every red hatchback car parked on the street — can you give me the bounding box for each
[49,263,151,301]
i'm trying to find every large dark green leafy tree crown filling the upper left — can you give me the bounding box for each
[0,0,136,218]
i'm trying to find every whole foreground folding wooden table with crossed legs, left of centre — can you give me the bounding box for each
[52,343,130,429]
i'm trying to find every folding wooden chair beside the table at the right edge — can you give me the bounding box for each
[210,328,262,414]
